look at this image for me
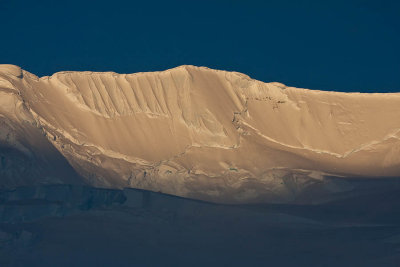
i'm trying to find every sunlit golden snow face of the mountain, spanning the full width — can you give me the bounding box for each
[0,65,400,203]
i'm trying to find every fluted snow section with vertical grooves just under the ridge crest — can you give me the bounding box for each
[54,69,203,121]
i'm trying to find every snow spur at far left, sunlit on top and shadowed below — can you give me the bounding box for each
[0,65,85,188]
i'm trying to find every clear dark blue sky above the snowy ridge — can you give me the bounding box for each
[0,0,400,92]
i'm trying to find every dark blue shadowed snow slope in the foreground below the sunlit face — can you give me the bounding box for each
[0,186,400,266]
